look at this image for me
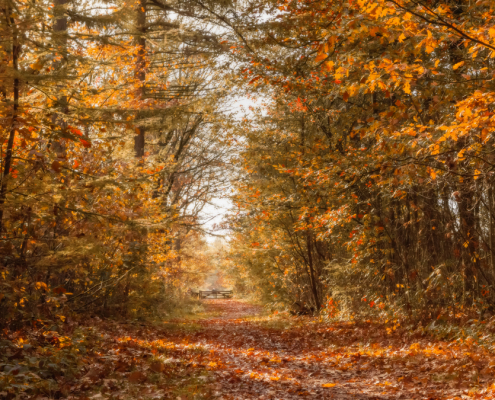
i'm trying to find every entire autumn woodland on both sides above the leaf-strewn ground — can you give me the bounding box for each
[0,0,495,393]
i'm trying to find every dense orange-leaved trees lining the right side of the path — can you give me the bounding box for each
[223,1,495,318]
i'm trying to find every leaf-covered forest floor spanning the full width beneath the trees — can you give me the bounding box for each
[0,300,495,400]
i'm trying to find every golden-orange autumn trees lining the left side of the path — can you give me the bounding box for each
[0,0,232,328]
